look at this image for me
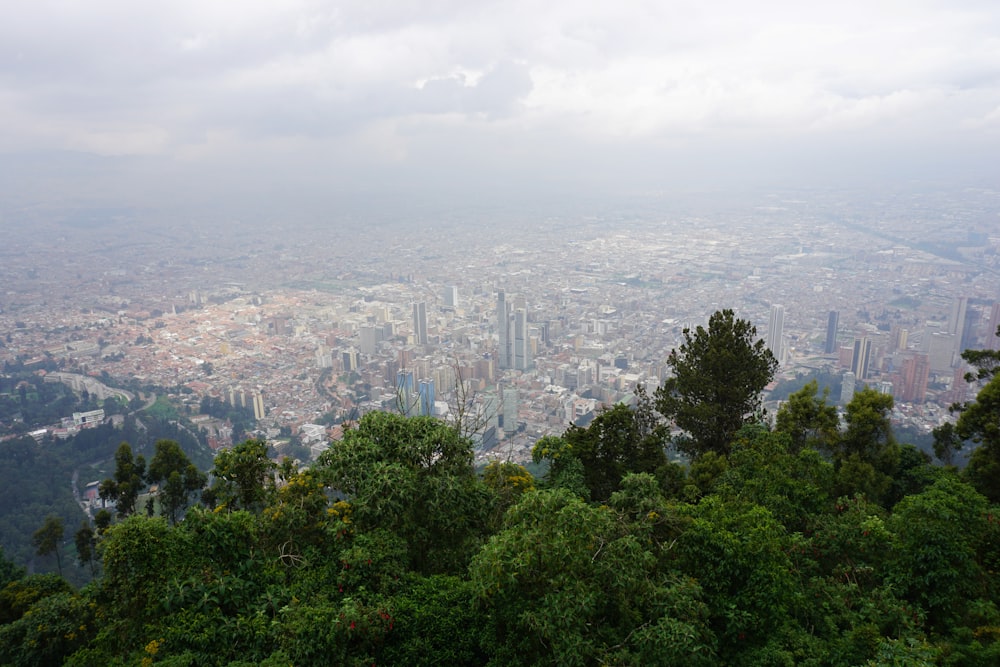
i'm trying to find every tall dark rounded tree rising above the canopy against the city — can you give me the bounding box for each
[656,310,778,456]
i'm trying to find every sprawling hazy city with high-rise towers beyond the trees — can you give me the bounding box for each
[0,187,1000,462]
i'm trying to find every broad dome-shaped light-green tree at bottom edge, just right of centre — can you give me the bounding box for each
[470,488,716,665]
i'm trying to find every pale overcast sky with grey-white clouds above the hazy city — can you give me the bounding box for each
[0,0,1000,214]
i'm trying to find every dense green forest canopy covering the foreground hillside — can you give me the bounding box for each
[0,320,1000,666]
